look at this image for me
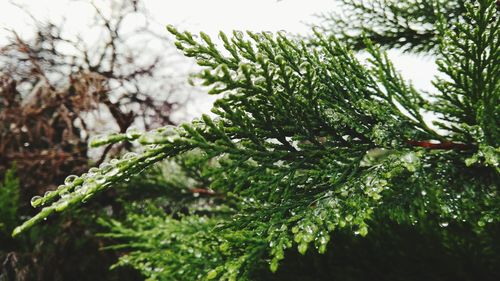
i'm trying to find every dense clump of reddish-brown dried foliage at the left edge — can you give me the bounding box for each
[0,74,101,202]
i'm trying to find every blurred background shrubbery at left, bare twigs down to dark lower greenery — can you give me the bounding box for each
[0,1,188,280]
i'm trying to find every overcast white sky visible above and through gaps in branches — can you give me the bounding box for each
[0,0,436,118]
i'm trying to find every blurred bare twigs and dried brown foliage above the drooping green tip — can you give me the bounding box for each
[0,1,182,199]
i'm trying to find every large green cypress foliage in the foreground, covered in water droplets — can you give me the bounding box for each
[9,0,500,280]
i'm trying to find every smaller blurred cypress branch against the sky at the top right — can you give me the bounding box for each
[314,0,466,53]
